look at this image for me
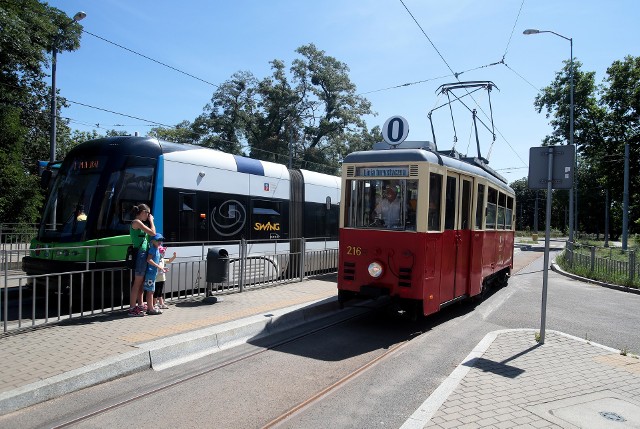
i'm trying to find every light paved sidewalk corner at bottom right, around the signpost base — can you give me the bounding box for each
[402,329,640,429]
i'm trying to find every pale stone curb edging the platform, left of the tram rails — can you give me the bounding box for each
[0,297,368,416]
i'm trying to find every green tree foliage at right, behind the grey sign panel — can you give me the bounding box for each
[534,56,640,238]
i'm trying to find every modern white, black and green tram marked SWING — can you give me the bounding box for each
[23,136,340,275]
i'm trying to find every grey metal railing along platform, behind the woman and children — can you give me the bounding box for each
[0,239,338,333]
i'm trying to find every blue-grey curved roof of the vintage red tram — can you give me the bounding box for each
[343,148,513,193]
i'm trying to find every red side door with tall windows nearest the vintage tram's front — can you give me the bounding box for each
[440,174,472,303]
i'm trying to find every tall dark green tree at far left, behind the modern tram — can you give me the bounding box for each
[0,0,81,222]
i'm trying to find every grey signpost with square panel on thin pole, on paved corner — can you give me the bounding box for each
[529,145,575,344]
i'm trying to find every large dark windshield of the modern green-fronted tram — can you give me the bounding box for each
[38,156,155,243]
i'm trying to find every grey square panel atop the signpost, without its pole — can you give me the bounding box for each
[529,145,575,189]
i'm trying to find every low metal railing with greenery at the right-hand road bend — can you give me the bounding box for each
[564,241,640,286]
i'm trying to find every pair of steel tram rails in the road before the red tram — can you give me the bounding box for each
[50,307,390,429]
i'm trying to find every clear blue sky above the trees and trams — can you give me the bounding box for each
[49,0,640,183]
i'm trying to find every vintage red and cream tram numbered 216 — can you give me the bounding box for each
[338,141,515,315]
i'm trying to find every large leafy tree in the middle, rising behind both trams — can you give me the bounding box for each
[191,44,378,174]
